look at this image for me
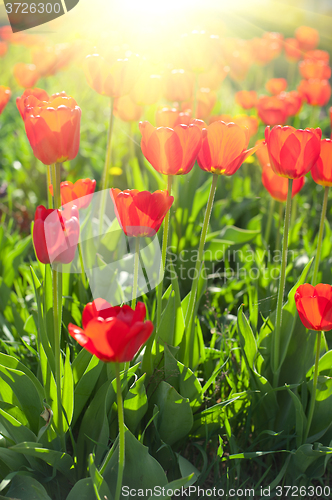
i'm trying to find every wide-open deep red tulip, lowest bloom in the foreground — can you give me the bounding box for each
[68,299,153,363]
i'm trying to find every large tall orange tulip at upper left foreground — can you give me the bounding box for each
[24,92,81,165]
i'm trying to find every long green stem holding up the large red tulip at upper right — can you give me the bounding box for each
[272,179,293,387]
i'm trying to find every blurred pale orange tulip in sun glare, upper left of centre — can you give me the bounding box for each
[84,54,139,97]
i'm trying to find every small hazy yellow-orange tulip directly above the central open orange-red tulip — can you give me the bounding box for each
[165,69,194,102]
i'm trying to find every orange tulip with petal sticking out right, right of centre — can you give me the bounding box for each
[194,121,258,175]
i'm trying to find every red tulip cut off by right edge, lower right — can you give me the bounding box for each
[294,283,332,332]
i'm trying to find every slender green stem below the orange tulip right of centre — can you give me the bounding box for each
[185,174,218,367]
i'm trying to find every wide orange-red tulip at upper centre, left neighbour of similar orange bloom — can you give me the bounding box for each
[139,122,204,175]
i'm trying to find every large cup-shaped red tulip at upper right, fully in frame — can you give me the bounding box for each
[265,125,322,179]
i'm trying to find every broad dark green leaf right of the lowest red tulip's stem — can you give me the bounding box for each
[150,381,193,445]
